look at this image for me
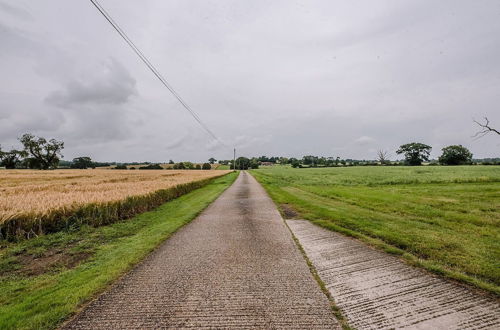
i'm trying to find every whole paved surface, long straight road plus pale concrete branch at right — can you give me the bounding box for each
[63,172,500,329]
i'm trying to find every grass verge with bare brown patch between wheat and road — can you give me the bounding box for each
[0,173,237,329]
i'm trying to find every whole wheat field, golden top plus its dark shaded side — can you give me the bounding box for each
[0,169,228,236]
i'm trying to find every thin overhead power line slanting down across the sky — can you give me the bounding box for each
[90,0,221,142]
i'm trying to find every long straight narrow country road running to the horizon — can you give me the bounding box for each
[64,172,340,329]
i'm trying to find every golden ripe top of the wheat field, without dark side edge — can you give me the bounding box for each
[0,169,228,224]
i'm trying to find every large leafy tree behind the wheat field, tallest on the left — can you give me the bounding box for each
[19,133,64,170]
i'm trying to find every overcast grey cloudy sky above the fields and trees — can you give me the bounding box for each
[0,0,500,161]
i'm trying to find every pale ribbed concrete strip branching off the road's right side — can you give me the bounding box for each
[287,220,500,329]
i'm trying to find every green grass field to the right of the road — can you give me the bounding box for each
[251,166,500,294]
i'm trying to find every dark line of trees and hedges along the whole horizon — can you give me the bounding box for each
[0,133,495,170]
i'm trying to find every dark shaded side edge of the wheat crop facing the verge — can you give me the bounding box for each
[0,174,227,241]
